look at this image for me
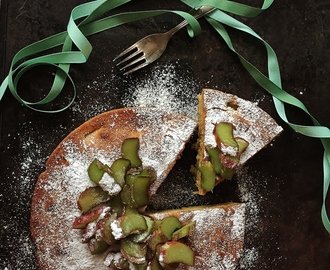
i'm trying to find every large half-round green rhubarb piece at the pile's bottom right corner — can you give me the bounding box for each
[159,241,195,266]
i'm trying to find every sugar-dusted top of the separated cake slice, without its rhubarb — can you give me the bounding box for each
[202,89,283,165]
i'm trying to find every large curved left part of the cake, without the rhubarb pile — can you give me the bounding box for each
[30,107,196,270]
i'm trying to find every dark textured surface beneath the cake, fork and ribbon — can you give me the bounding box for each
[0,0,330,270]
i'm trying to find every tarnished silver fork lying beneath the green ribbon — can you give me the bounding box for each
[113,6,215,75]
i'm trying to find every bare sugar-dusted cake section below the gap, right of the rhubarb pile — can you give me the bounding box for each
[151,203,245,270]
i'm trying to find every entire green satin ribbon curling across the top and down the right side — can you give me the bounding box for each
[0,0,330,233]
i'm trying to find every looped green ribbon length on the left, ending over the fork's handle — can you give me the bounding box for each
[0,0,201,113]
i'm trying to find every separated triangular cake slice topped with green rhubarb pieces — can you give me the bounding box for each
[196,89,283,195]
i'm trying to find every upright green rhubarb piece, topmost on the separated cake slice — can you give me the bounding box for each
[214,122,238,156]
